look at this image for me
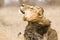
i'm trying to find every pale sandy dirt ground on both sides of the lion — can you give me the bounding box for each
[0,6,60,40]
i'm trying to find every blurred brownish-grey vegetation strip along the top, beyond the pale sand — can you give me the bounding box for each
[0,0,60,6]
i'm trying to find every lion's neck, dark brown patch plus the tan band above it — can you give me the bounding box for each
[28,17,50,35]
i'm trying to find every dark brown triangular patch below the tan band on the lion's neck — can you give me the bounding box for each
[28,22,50,36]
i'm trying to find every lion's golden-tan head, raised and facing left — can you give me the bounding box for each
[20,4,44,22]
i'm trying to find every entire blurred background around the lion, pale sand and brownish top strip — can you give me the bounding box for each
[0,0,60,40]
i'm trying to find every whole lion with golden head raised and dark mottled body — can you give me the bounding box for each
[20,4,58,40]
